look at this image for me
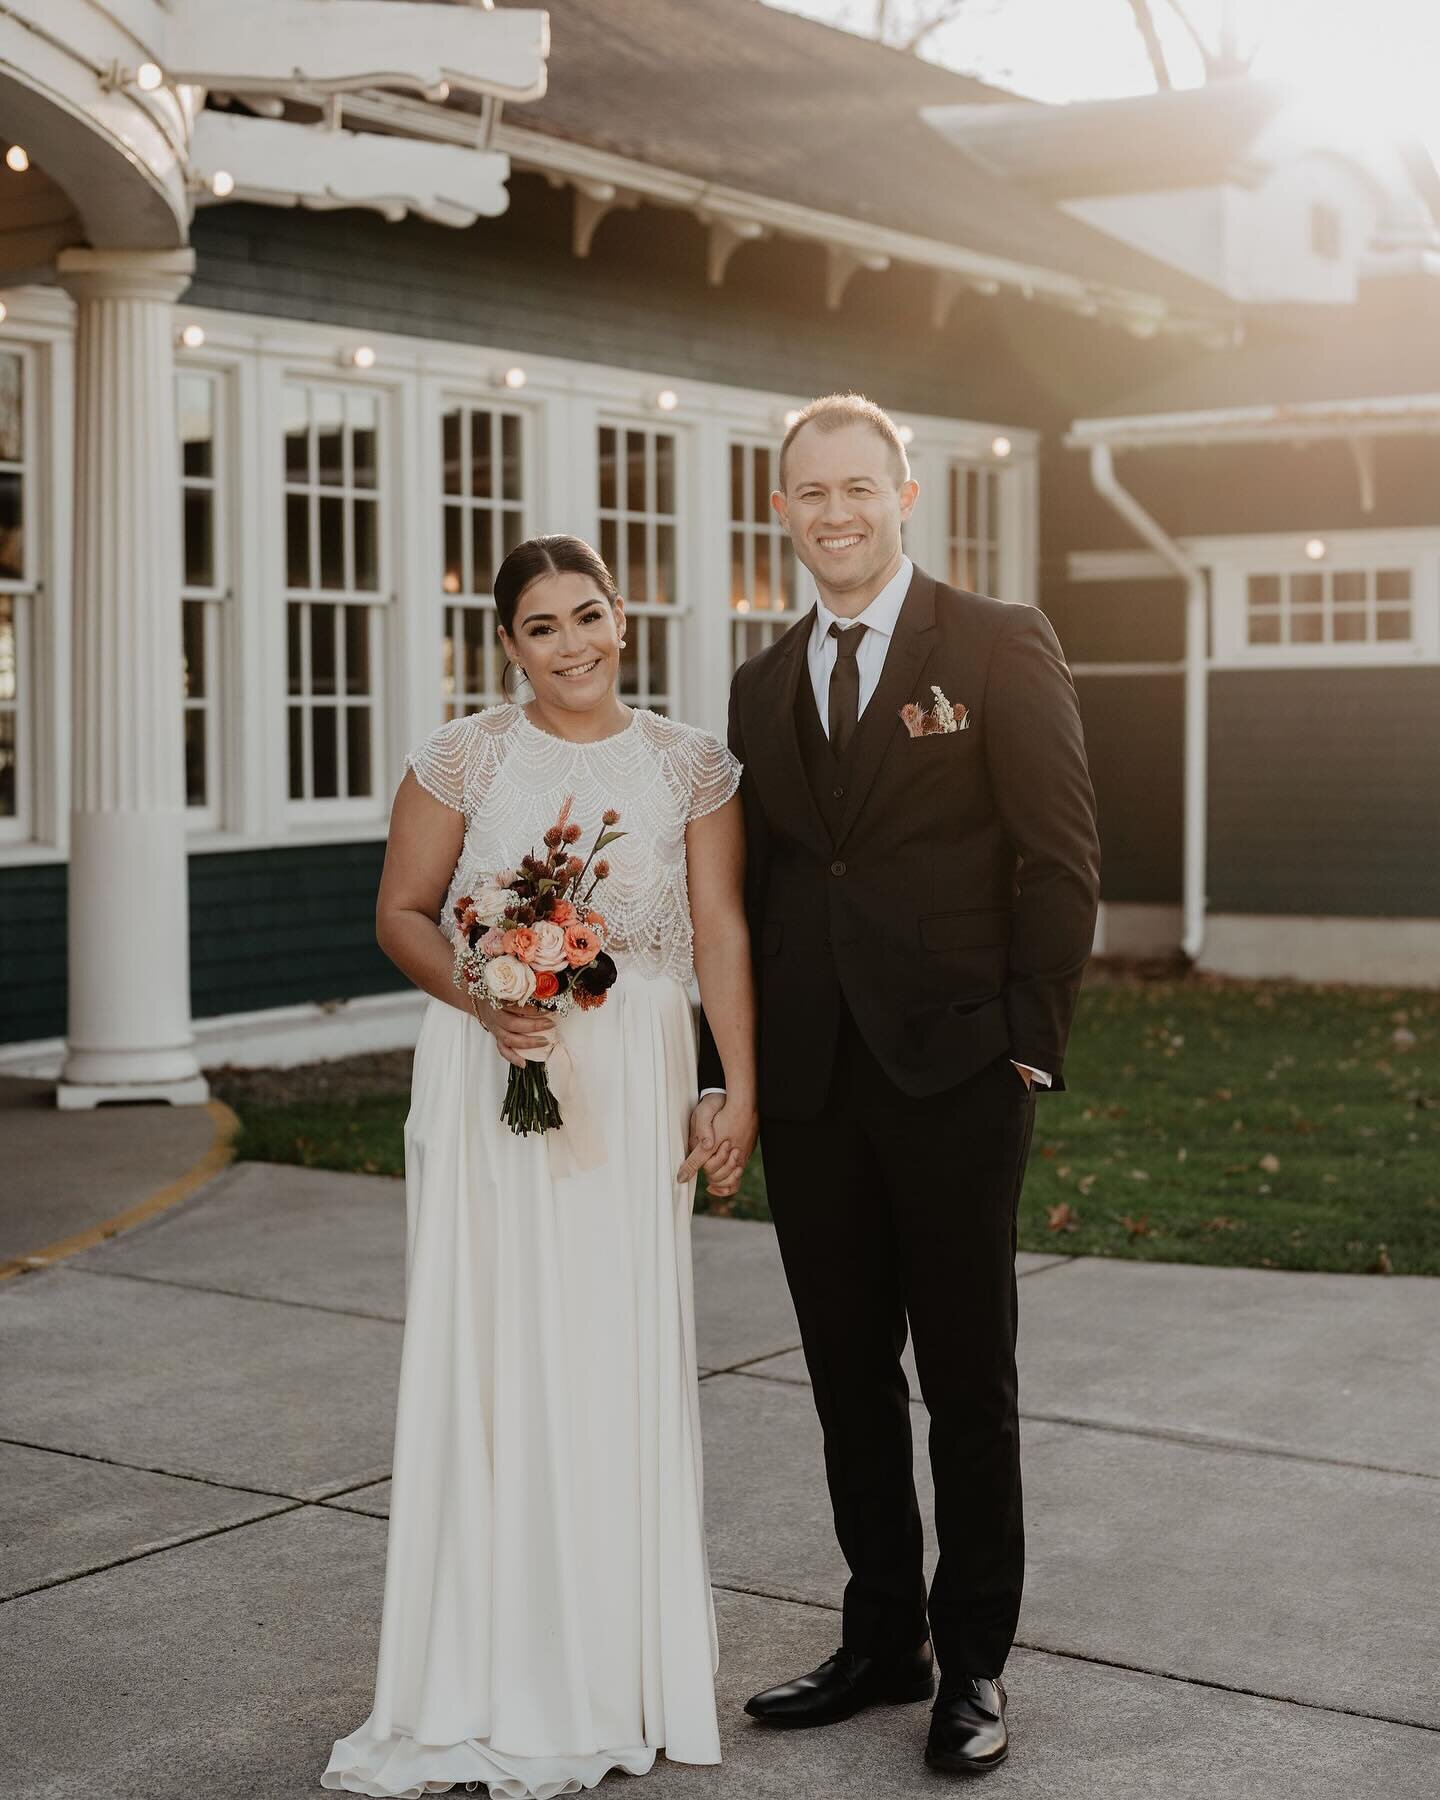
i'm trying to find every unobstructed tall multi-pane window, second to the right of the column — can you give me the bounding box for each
[284,383,382,801]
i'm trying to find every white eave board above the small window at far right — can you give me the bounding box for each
[1066,394,1440,450]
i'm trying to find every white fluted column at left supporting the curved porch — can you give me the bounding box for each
[56,250,209,1107]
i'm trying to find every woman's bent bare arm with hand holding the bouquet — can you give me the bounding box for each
[374,770,553,1062]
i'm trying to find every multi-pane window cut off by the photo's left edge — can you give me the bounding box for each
[0,349,34,837]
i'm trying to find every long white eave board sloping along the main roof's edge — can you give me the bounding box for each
[493,121,1219,333]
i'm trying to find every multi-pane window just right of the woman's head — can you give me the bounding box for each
[598,425,680,713]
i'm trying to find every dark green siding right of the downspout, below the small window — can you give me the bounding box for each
[1208,668,1440,918]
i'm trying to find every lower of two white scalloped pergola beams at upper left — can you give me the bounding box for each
[191,112,509,225]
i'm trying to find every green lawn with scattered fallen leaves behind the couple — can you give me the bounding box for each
[220,976,1440,1274]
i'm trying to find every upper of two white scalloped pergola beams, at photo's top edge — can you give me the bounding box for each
[166,0,549,101]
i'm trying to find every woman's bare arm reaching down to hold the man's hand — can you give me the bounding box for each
[680,796,758,1193]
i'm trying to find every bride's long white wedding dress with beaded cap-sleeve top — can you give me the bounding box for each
[322,706,740,1800]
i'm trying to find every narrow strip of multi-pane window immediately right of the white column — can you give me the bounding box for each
[175,374,227,823]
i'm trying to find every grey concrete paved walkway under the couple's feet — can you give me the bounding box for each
[0,1144,1440,1800]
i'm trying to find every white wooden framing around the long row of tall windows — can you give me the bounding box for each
[0,298,1039,866]
